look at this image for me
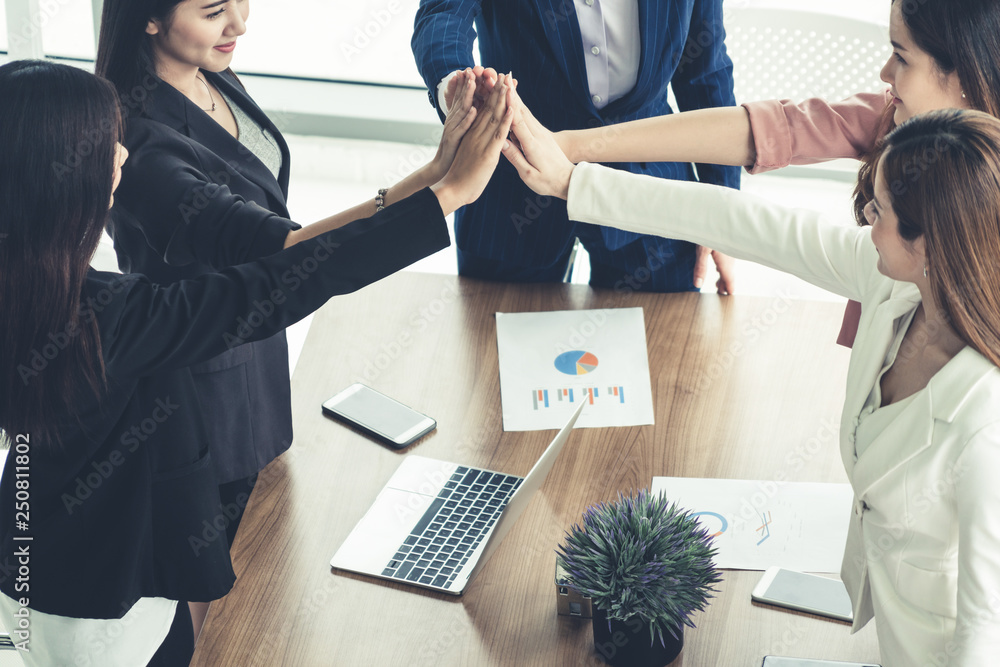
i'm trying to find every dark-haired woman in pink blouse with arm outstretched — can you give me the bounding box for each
[556,0,1000,347]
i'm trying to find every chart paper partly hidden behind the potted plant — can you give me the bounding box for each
[651,477,854,573]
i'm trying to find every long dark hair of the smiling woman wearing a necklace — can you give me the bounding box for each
[94,0,242,114]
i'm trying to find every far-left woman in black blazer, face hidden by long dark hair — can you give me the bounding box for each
[0,61,511,667]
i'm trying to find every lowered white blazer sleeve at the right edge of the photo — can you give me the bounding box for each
[948,423,1000,667]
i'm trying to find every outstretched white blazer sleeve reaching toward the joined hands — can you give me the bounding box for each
[568,163,885,301]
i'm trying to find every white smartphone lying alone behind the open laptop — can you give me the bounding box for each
[323,383,437,449]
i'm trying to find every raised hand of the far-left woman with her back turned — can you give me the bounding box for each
[431,75,514,215]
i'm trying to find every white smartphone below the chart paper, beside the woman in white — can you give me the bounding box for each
[750,567,854,623]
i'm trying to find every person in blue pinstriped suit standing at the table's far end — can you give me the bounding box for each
[411,0,740,293]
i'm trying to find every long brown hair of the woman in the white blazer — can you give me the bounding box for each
[878,109,1000,366]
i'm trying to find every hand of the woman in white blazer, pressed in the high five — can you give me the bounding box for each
[503,84,575,199]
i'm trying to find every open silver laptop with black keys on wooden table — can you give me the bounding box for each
[330,402,586,595]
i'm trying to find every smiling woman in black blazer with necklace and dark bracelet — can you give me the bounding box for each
[97,0,486,648]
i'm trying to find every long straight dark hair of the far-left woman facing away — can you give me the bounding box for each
[0,60,121,443]
